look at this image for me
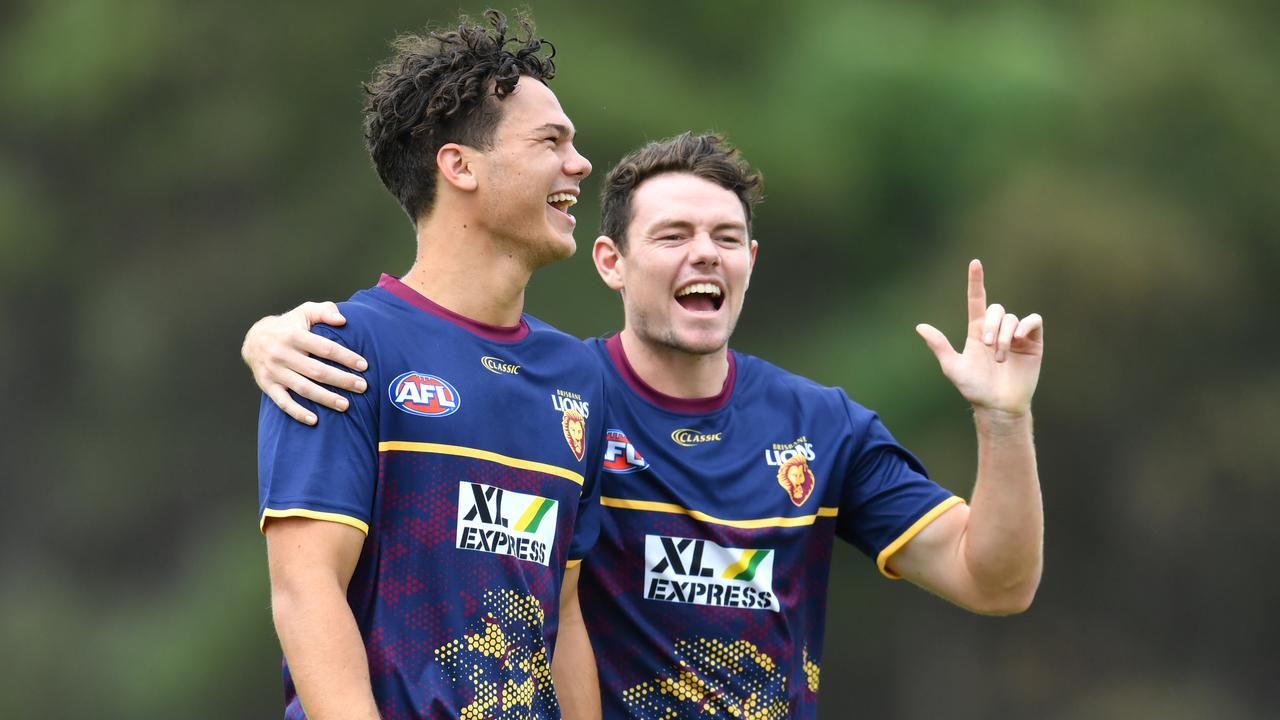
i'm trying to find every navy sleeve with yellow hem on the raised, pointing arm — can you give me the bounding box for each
[836,389,963,579]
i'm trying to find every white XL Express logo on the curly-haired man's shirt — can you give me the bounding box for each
[457,482,558,565]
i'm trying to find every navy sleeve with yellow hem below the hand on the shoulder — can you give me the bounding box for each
[257,325,379,534]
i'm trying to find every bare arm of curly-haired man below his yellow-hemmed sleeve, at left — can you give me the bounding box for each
[266,518,378,720]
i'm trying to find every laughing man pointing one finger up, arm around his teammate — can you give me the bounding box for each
[246,133,1043,719]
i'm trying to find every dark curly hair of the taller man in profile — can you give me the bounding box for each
[365,10,556,222]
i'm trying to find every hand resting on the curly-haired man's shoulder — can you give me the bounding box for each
[241,302,369,425]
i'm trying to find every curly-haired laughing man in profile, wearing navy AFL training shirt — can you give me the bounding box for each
[259,12,604,720]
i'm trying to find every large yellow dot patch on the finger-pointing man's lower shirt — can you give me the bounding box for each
[622,638,790,720]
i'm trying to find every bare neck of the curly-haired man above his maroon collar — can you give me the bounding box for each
[401,213,532,327]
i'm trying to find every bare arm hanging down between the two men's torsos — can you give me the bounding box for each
[552,565,602,720]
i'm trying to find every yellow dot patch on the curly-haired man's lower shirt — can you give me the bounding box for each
[435,589,559,720]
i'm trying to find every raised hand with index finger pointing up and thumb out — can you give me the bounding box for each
[915,260,1044,415]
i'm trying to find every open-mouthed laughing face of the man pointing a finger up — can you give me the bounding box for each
[604,173,756,355]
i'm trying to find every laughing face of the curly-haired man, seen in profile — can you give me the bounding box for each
[476,77,591,266]
